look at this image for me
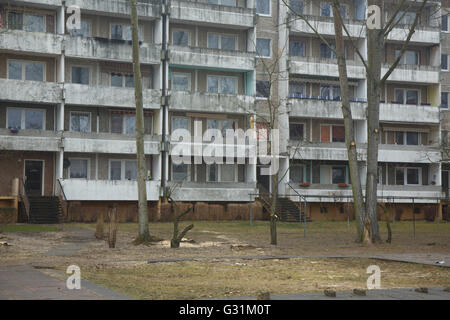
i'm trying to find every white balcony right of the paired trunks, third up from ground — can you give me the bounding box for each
[380,103,439,124]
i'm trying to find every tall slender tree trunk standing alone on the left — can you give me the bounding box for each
[130,0,151,243]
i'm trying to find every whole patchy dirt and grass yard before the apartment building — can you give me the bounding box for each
[0,221,450,299]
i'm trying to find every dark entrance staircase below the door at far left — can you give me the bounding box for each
[28,197,62,224]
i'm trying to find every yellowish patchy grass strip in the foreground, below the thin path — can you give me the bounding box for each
[82,259,450,299]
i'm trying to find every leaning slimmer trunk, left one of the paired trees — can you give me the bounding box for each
[333,2,367,242]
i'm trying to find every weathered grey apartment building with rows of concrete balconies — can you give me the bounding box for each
[0,0,442,221]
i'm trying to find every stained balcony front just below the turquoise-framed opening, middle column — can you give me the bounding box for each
[170,91,255,114]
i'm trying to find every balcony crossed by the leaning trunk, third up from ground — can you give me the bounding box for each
[289,97,366,120]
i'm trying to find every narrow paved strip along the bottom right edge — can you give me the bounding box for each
[218,287,450,300]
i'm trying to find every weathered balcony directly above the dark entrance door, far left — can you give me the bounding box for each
[0,128,61,152]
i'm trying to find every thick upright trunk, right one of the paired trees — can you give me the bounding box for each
[366,0,383,242]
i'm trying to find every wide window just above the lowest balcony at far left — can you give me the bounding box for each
[6,108,45,130]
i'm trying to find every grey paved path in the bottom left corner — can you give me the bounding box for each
[0,265,130,300]
